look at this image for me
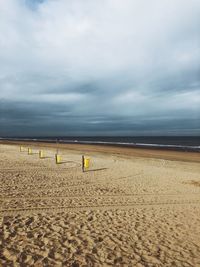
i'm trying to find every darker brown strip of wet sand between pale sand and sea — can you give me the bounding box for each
[0,140,200,163]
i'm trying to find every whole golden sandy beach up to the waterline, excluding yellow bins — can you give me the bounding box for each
[0,144,200,267]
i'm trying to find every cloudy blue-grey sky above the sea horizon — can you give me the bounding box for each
[0,0,200,136]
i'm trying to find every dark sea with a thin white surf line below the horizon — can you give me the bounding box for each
[0,136,200,152]
